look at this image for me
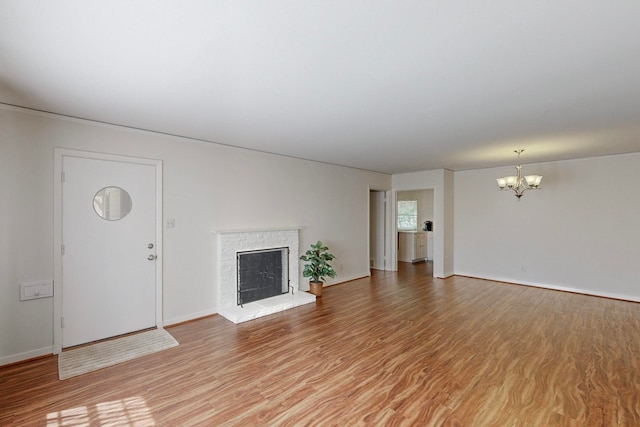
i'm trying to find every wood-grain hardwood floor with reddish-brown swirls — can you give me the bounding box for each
[0,263,640,427]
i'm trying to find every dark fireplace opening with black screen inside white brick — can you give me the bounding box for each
[236,248,289,306]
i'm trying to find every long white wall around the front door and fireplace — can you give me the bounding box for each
[0,107,391,365]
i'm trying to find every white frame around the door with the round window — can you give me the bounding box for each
[53,147,163,354]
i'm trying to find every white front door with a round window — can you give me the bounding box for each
[61,157,156,347]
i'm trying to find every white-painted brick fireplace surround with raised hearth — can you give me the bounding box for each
[215,227,315,323]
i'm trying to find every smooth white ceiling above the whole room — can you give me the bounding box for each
[0,0,640,173]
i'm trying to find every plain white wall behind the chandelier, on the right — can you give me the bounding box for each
[454,154,640,301]
